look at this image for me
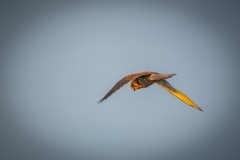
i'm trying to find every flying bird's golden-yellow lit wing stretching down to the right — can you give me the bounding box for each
[156,79,203,111]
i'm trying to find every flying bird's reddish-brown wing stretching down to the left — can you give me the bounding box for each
[98,72,153,103]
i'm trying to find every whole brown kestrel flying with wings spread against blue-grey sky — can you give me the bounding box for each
[98,72,203,111]
